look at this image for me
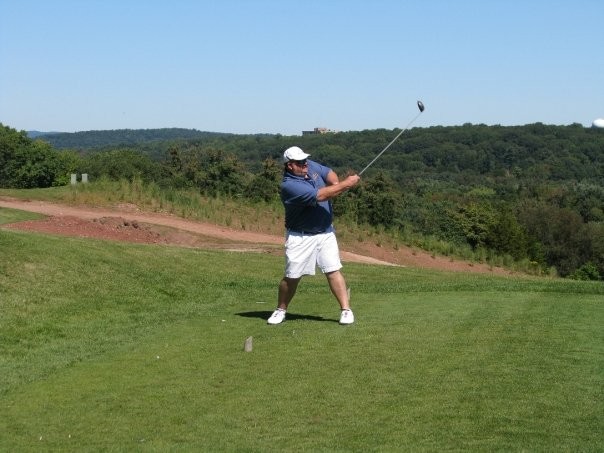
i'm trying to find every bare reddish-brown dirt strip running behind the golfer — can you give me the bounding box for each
[0,197,510,275]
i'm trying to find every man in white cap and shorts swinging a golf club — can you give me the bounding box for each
[267,146,361,324]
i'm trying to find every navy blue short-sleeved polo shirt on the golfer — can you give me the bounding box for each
[281,160,333,234]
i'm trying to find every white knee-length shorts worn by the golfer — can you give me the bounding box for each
[285,231,342,278]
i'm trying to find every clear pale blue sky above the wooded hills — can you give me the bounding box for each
[0,0,604,135]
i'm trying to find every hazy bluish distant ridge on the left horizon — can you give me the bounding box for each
[28,128,234,150]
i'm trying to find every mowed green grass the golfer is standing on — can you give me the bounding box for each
[0,222,604,452]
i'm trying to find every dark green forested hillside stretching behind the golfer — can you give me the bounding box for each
[0,123,604,279]
